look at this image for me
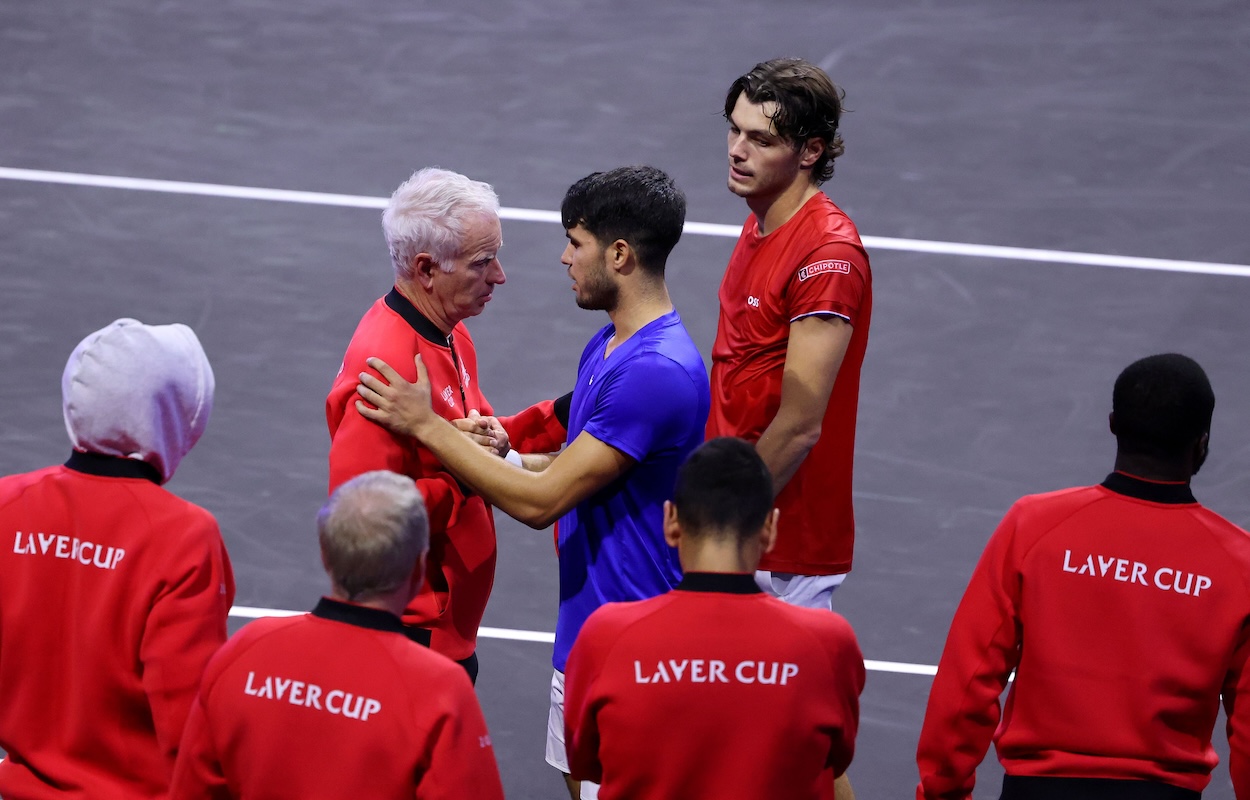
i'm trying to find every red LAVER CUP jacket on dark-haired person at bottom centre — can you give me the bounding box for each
[564,573,864,800]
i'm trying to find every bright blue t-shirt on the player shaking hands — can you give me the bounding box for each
[553,311,711,671]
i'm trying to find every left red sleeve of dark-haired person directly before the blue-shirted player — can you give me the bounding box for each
[564,609,606,784]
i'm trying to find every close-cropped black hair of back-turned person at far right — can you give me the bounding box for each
[1111,353,1215,459]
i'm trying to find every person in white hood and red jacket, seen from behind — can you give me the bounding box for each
[0,319,235,799]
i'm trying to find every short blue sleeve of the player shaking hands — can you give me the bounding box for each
[584,353,703,461]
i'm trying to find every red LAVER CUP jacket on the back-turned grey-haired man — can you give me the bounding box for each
[170,599,504,800]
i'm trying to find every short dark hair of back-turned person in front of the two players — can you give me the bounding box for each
[673,436,773,541]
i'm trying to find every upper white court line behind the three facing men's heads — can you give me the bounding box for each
[0,166,1250,278]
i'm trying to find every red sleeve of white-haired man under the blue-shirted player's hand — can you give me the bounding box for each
[330,392,464,534]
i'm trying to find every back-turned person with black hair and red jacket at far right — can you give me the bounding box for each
[916,354,1250,800]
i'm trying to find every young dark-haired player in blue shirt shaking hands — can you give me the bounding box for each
[356,166,710,800]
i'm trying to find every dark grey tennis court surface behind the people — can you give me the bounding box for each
[0,0,1250,800]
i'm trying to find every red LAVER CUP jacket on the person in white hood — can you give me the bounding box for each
[0,453,235,800]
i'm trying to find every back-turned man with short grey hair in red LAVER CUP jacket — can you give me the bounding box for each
[171,471,504,800]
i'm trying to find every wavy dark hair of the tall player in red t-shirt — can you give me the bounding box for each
[725,59,846,185]
